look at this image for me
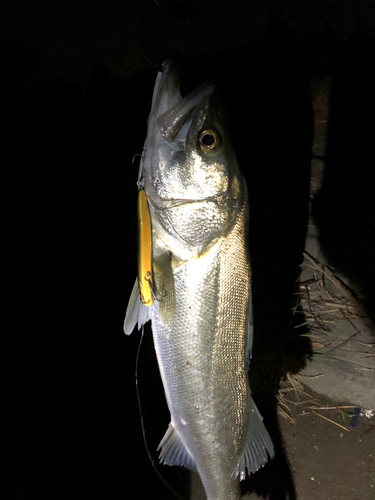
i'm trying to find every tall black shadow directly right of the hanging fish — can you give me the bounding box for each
[232,43,313,500]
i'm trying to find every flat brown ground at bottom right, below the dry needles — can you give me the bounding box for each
[280,388,375,500]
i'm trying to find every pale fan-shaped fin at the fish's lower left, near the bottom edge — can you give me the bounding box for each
[158,422,196,470]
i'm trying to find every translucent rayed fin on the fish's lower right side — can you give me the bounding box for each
[238,396,275,479]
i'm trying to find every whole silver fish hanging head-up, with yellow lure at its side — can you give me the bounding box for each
[124,60,274,500]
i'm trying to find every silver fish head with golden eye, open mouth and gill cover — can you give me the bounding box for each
[138,61,244,260]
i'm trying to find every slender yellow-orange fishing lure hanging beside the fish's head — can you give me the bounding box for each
[138,189,154,306]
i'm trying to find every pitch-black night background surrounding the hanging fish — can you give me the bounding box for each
[0,0,375,500]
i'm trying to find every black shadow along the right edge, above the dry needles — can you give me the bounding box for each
[313,40,375,321]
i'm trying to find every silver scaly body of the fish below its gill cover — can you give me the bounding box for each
[152,207,250,500]
